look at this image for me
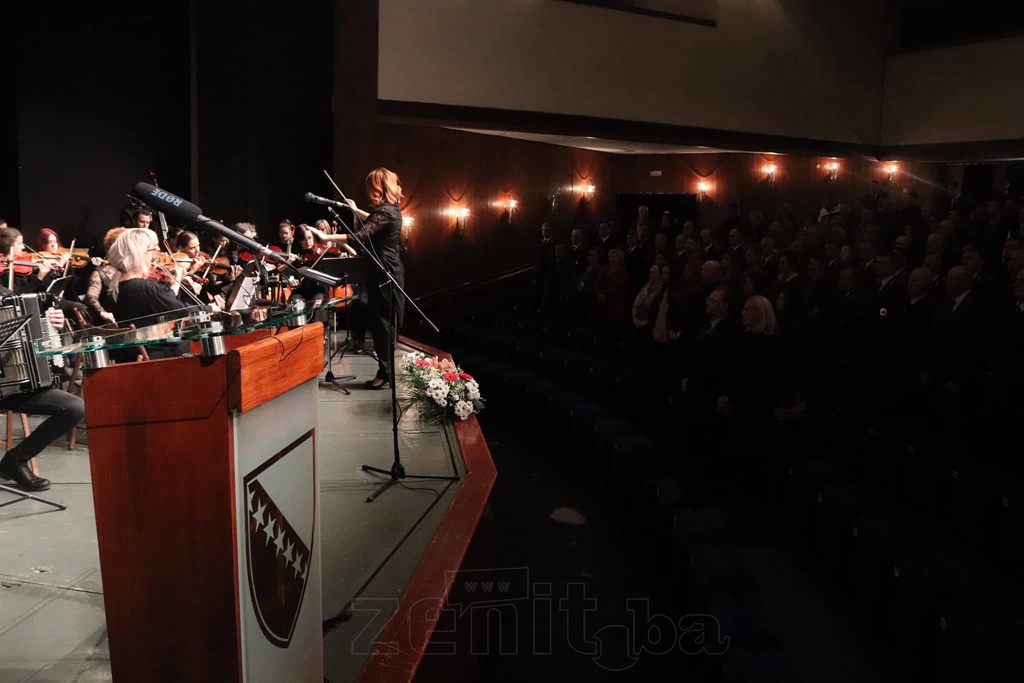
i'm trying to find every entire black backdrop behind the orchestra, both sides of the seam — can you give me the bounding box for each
[8,0,333,250]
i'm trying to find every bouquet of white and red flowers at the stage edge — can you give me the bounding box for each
[398,351,483,424]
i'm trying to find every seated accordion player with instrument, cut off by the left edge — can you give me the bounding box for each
[0,287,85,492]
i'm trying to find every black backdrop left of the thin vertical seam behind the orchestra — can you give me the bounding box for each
[4,3,188,245]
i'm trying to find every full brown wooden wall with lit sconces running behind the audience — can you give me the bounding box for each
[358,122,944,297]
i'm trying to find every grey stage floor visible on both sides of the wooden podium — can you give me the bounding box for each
[0,347,465,683]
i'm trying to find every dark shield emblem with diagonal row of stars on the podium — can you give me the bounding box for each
[244,430,316,647]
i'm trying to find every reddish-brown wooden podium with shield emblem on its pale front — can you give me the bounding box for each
[84,323,324,683]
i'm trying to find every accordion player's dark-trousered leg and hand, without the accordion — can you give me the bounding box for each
[0,294,85,490]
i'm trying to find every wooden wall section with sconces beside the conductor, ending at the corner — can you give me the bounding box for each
[378,123,614,296]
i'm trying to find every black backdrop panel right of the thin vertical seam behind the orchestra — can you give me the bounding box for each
[192,0,334,240]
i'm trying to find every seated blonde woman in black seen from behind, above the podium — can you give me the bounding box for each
[106,228,188,358]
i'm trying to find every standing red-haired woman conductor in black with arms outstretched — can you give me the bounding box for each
[308,168,406,389]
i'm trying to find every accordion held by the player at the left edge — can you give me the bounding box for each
[0,294,63,397]
